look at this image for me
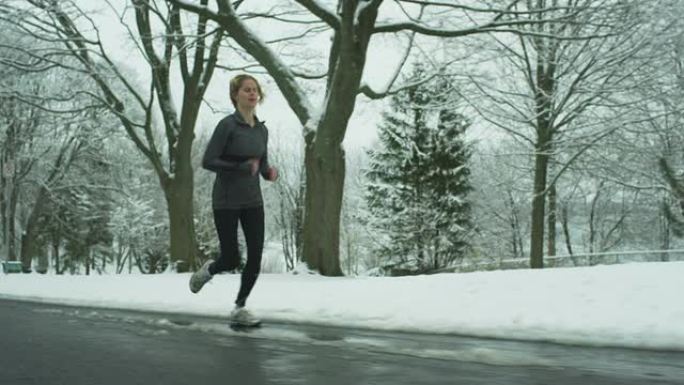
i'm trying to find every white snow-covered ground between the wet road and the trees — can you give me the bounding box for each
[0,262,684,351]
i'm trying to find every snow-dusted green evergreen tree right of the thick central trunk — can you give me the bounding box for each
[366,67,472,273]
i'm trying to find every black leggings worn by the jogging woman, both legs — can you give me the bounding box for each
[209,206,264,306]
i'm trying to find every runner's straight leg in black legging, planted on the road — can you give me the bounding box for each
[235,206,264,307]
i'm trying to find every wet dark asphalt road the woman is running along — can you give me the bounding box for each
[0,300,684,385]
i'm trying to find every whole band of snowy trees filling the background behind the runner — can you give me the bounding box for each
[0,0,684,275]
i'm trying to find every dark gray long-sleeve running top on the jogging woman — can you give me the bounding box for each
[202,111,269,209]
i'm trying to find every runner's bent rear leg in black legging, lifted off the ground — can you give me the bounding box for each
[209,209,240,275]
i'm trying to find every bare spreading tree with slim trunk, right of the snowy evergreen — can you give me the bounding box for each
[464,0,649,268]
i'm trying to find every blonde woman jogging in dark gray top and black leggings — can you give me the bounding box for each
[190,75,278,326]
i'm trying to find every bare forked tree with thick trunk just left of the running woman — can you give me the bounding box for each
[9,0,223,271]
